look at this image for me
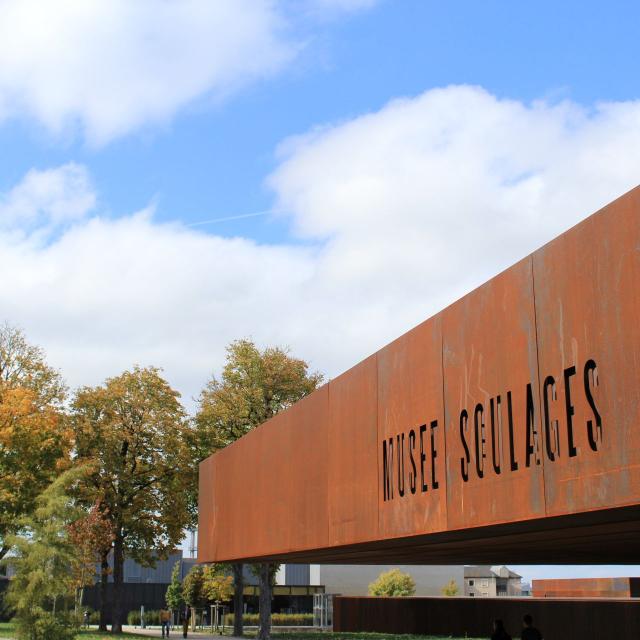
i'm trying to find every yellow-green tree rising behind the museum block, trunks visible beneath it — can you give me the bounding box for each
[195,340,322,639]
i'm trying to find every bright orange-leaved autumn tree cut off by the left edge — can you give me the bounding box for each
[0,324,70,559]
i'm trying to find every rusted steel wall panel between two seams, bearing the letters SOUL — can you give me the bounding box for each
[443,258,545,529]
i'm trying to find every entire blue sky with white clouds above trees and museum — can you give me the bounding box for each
[0,0,640,577]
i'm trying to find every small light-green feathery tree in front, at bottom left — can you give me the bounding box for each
[7,469,82,640]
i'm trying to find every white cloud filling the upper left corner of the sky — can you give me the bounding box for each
[0,0,376,144]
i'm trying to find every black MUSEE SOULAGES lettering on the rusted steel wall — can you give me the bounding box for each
[382,359,602,502]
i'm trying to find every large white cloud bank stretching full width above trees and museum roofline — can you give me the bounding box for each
[0,87,640,398]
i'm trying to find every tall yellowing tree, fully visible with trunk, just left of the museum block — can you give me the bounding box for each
[71,367,195,633]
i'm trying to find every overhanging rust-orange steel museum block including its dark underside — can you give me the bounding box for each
[198,187,640,563]
